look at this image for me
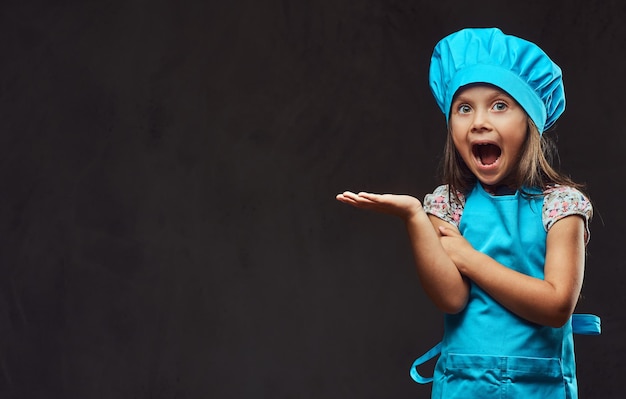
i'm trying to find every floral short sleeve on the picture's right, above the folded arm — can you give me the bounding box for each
[543,186,593,244]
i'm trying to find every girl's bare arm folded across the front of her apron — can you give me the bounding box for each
[440,215,585,327]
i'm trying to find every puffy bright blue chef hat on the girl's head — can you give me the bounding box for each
[430,28,565,133]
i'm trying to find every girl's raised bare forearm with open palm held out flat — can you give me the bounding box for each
[337,191,469,313]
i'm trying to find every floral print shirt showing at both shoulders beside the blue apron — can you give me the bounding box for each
[424,184,593,244]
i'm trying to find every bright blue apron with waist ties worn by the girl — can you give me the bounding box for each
[411,184,600,399]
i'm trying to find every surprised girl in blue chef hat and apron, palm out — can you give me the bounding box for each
[337,28,599,399]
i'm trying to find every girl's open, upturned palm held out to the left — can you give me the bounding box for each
[337,191,422,220]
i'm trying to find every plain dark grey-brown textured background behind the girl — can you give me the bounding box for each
[0,0,626,399]
